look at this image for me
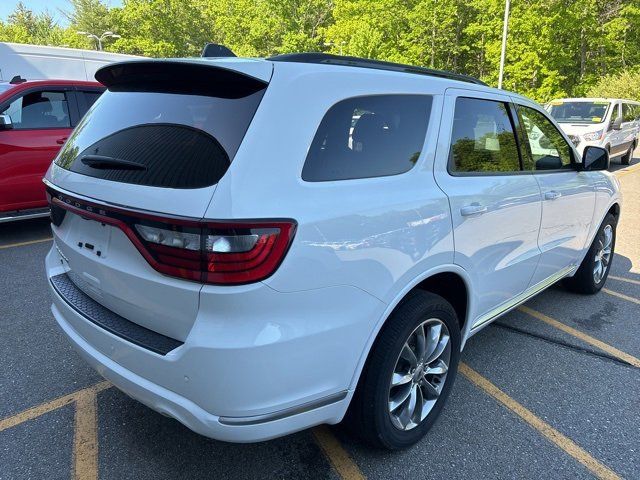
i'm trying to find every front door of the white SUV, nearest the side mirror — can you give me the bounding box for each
[517,104,595,286]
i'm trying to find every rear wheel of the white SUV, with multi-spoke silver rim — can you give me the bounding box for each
[346,290,460,450]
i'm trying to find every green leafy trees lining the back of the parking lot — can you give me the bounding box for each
[0,0,640,101]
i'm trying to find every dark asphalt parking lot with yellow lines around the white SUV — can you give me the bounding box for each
[0,155,640,480]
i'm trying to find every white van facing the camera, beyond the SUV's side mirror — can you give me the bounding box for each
[547,98,640,165]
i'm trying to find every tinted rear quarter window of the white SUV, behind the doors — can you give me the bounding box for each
[302,95,431,182]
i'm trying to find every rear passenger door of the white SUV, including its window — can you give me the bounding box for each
[434,89,542,328]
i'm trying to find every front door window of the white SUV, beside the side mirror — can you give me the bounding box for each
[518,106,572,170]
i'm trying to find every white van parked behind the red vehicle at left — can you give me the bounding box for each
[0,42,140,82]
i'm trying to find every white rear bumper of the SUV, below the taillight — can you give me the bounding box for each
[46,246,382,442]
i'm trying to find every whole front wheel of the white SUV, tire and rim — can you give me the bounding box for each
[564,213,617,294]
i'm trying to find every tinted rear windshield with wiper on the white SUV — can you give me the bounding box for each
[55,82,266,188]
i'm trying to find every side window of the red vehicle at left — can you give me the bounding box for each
[0,91,71,130]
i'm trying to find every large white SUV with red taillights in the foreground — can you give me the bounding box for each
[45,54,620,448]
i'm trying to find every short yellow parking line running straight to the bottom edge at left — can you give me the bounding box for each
[73,389,98,480]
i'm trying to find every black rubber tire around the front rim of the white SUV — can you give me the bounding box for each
[563,213,617,294]
